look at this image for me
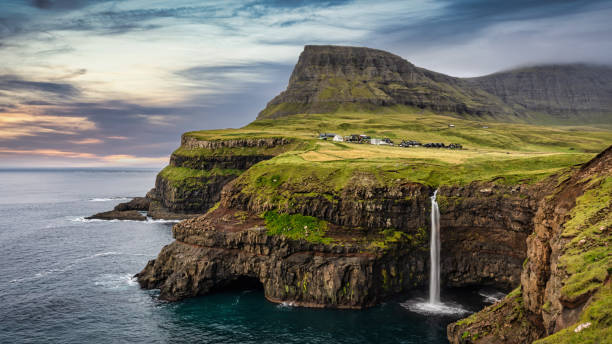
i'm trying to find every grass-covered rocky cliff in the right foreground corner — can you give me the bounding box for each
[448,147,612,343]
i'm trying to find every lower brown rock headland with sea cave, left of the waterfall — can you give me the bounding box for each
[137,209,426,308]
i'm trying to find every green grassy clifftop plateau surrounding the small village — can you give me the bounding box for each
[175,108,612,189]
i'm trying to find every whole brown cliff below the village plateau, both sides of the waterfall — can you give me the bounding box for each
[138,175,540,308]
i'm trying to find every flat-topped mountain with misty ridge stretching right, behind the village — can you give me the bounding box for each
[258,45,612,123]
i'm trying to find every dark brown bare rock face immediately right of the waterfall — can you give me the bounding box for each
[438,182,544,290]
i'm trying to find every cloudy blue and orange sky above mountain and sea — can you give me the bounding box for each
[0,0,612,168]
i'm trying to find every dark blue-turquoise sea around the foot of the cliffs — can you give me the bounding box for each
[0,170,498,343]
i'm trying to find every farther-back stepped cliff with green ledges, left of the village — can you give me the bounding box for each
[147,134,291,218]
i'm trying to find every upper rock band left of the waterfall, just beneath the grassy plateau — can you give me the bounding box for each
[221,174,433,231]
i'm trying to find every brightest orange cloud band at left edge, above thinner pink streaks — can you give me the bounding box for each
[0,113,96,139]
